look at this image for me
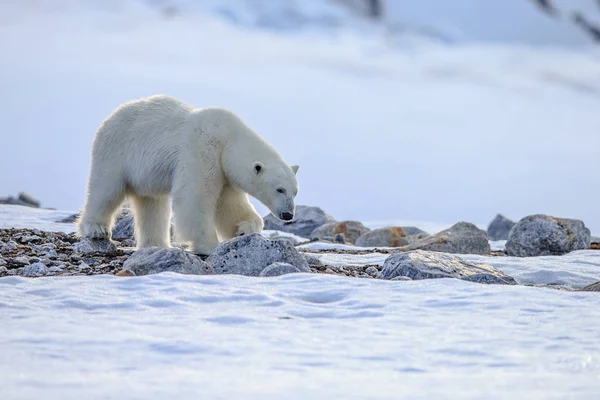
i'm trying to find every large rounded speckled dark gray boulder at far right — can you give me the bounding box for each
[506,214,590,257]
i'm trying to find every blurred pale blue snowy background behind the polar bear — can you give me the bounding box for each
[0,0,600,234]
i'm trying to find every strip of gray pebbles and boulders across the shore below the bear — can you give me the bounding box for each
[0,206,600,291]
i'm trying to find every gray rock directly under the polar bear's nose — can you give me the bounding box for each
[263,206,335,238]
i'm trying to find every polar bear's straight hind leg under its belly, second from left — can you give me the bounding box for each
[129,194,171,249]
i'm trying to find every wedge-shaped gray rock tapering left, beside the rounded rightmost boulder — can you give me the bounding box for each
[400,222,491,254]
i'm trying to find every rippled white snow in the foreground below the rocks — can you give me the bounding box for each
[0,273,600,400]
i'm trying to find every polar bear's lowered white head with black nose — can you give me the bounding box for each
[248,161,299,221]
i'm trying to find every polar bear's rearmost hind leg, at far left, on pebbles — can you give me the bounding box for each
[77,180,125,239]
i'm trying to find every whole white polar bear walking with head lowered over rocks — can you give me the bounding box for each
[77,95,299,254]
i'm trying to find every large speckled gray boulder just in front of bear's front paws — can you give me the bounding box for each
[206,233,311,276]
